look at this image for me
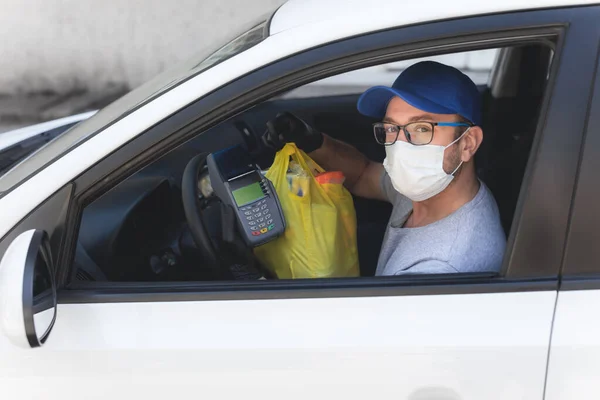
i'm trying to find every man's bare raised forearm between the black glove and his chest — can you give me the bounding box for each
[309,134,388,201]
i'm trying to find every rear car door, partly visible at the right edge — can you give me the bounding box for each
[546,42,600,400]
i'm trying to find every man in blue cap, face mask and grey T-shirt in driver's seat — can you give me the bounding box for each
[264,61,506,275]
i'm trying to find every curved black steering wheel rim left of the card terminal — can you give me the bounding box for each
[181,153,221,271]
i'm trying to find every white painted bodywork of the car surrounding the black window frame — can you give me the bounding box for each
[0,0,600,400]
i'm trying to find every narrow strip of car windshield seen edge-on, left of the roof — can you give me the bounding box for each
[0,16,268,197]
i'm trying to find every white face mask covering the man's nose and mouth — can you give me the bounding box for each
[383,129,469,201]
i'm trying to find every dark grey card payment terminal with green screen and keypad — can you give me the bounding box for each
[206,146,285,247]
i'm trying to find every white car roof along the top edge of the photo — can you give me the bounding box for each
[270,0,599,35]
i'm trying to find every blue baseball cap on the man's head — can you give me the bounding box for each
[357,61,481,125]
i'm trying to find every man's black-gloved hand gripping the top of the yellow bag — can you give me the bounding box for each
[262,112,323,153]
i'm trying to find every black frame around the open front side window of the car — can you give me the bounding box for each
[7,7,600,303]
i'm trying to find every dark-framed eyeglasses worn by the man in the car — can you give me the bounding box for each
[373,122,473,146]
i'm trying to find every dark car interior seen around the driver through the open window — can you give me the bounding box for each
[72,43,553,282]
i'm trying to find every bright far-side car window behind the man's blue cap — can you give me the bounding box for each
[280,49,499,99]
